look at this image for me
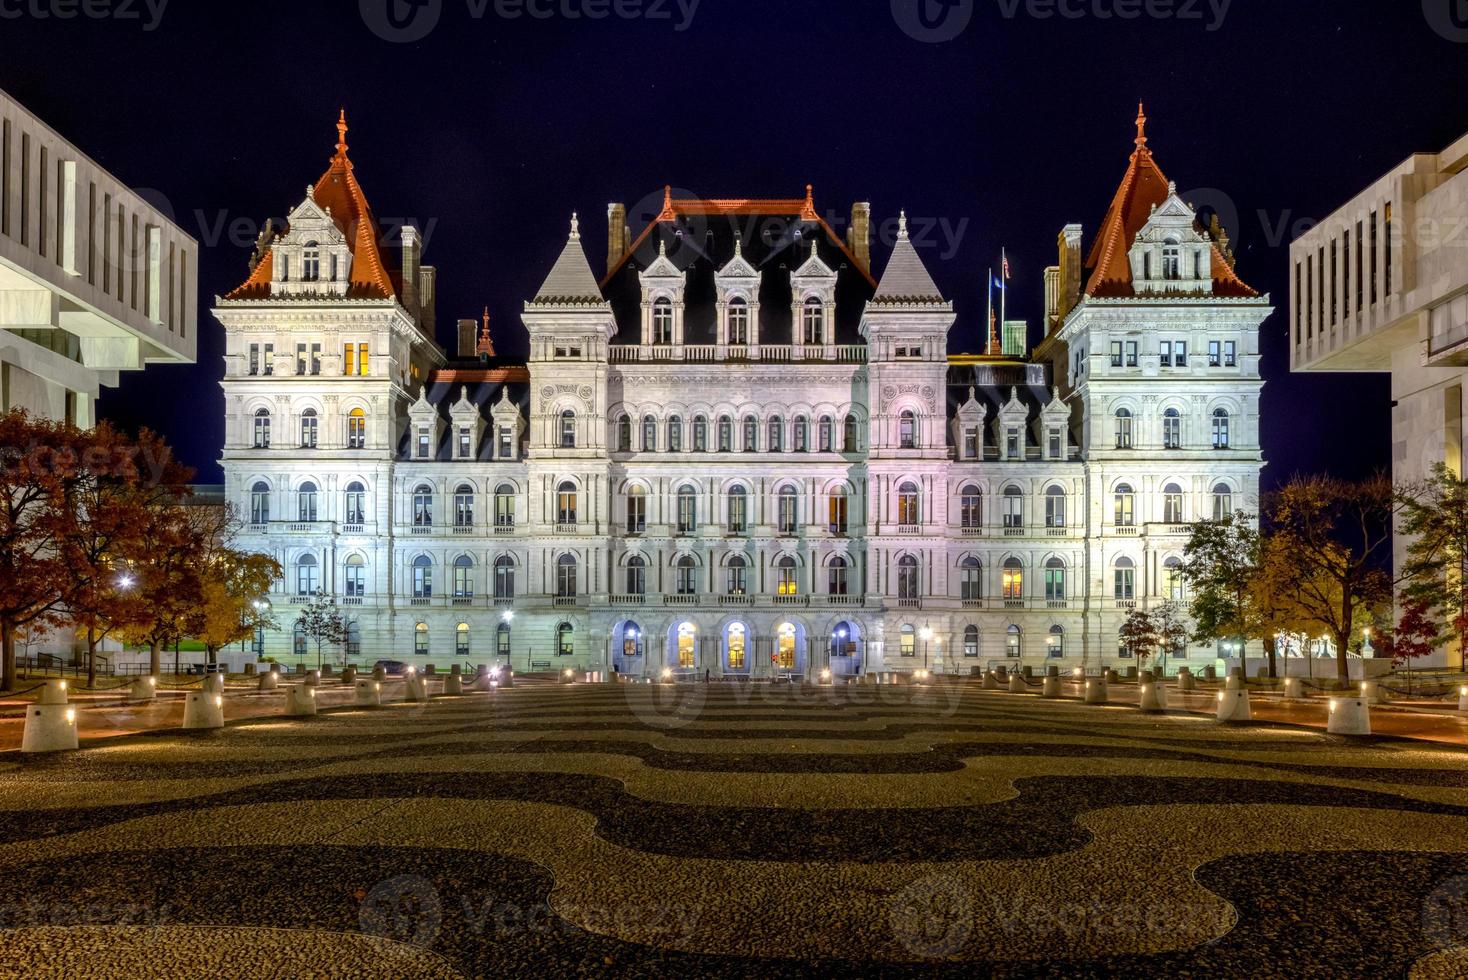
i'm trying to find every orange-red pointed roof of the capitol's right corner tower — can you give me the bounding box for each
[1086,106,1260,298]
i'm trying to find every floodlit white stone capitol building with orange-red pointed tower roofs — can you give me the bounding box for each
[213,105,1271,678]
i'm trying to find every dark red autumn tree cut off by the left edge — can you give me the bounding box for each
[0,409,85,691]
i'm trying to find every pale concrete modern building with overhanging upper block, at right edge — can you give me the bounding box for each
[1290,124,1468,674]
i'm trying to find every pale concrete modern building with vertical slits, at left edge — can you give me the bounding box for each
[0,91,198,427]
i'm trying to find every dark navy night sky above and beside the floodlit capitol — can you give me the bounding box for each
[0,0,1468,483]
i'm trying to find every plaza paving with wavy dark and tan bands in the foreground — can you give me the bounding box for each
[0,684,1468,977]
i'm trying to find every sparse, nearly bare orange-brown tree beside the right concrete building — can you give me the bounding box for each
[1268,475,1399,685]
